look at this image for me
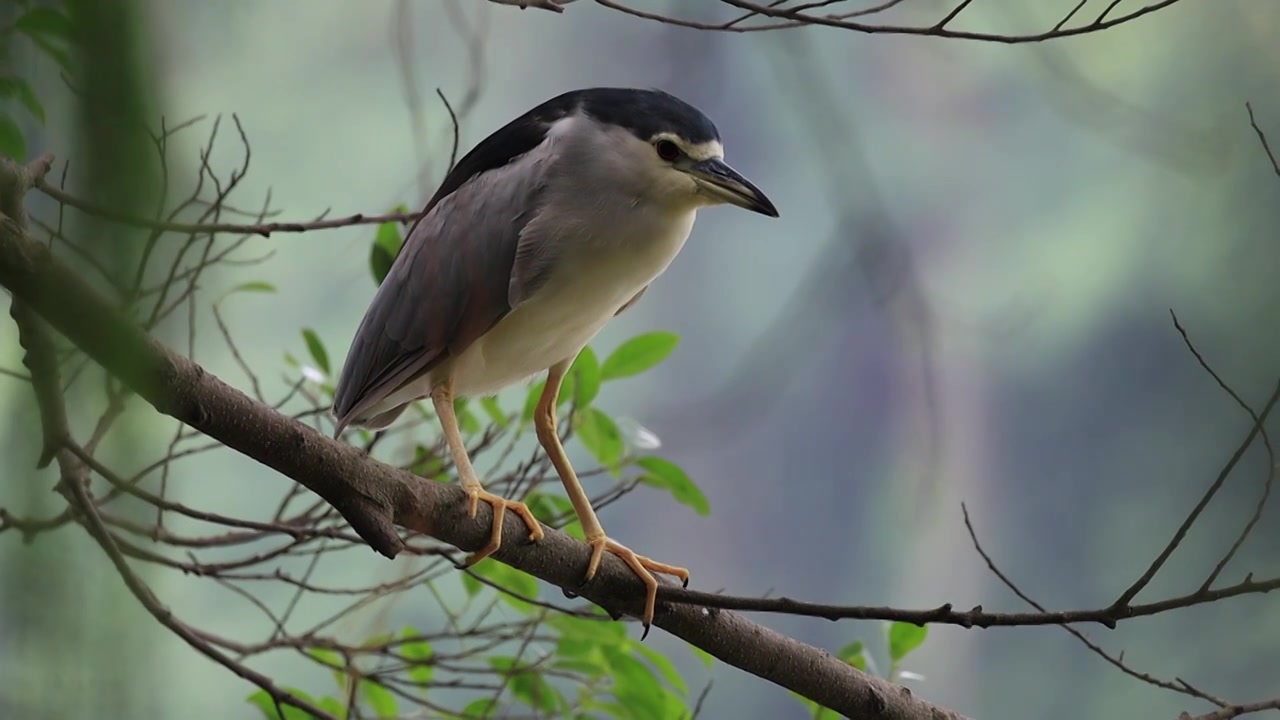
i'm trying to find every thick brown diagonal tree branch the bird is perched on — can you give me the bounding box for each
[0,154,960,720]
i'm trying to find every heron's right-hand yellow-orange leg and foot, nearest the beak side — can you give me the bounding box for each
[534,359,689,633]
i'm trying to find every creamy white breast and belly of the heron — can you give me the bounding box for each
[445,210,694,396]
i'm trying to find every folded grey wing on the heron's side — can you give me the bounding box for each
[334,152,544,432]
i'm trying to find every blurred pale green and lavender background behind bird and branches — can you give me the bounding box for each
[0,0,1280,720]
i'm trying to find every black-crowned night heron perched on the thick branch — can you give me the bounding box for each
[334,87,778,629]
